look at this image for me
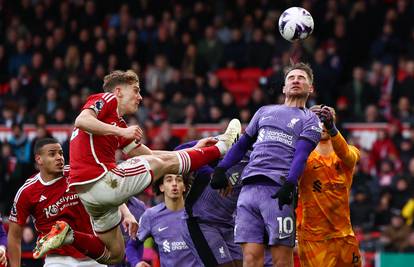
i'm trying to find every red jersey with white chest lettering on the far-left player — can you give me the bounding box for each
[9,168,94,259]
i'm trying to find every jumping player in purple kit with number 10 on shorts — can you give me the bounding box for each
[211,63,322,266]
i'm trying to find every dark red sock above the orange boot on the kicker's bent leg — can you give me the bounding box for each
[71,231,106,260]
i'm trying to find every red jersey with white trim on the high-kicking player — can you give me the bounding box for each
[69,93,133,186]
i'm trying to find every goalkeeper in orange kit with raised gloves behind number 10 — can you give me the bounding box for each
[297,106,361,267]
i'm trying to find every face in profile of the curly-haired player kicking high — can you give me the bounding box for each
[119,83,142,114]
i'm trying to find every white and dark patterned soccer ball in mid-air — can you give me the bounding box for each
[279,7,314,42]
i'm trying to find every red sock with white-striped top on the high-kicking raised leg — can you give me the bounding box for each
[178,146,221,173]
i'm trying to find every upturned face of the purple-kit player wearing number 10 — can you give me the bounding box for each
[283,69,313,97]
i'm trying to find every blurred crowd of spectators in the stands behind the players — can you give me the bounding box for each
[0,0,414,262]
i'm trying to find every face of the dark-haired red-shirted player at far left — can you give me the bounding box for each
[35,144,65,175]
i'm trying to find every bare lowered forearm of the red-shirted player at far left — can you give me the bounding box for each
[7,222,23,267]
